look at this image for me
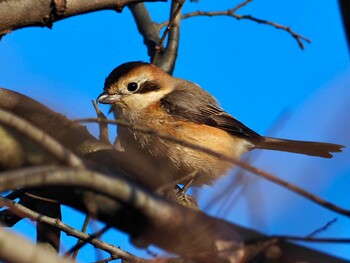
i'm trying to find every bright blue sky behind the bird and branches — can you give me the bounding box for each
[0,0,350,261]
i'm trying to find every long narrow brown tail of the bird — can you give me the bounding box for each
[255,137,345,158]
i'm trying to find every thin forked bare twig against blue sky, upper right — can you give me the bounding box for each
[159,0,311,49]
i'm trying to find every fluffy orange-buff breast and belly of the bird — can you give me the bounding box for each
[118,102,251,185]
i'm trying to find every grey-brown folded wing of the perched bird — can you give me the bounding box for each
[161,83,263,141]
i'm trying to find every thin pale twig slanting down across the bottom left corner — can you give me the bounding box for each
[0,196,146,263]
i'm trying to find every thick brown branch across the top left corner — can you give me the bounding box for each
[0,0,166,38]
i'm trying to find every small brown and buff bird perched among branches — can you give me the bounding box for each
[97,62,344,186]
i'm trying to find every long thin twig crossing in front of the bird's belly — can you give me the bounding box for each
[75,118,350,220]
